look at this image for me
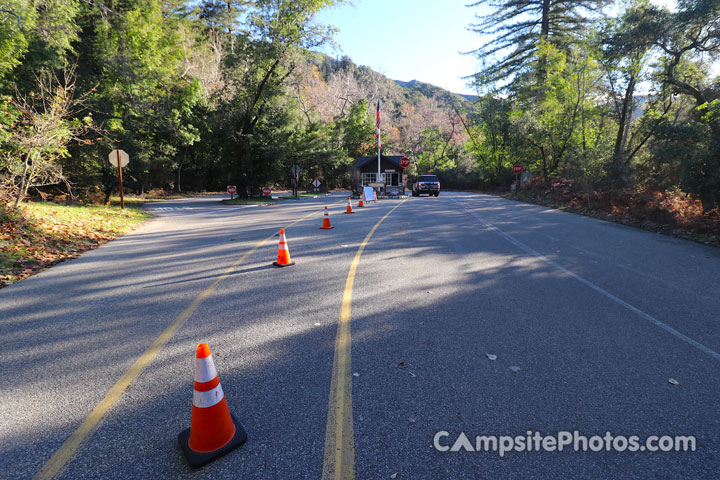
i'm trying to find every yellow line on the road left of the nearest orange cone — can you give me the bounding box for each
[33,203,322,480]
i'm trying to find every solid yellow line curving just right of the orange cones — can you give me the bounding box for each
[323,200,406,480]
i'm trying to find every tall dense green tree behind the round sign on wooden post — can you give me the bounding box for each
[71,0,202,196]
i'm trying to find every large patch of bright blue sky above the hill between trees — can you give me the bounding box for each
[318,0,481,93]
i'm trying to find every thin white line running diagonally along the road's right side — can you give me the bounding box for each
[452,199,720,361]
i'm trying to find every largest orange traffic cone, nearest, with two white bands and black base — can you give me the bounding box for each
[178,343,247,468]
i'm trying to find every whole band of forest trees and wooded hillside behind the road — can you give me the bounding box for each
[0,0,720,213]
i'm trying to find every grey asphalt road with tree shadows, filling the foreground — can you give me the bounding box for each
[0,192,720,479]
